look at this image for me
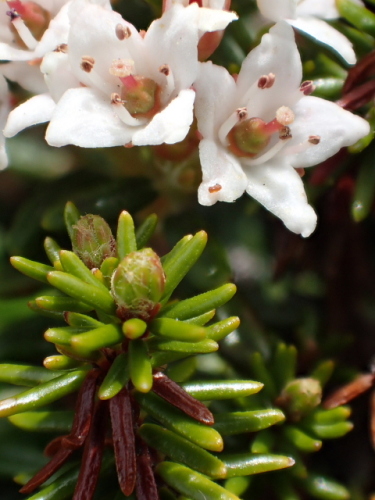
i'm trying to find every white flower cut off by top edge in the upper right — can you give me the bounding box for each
[257,0,363,64]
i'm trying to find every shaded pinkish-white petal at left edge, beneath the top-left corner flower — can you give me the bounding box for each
[1,61,47,94]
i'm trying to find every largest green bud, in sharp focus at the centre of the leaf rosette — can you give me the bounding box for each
[111,248,165,321]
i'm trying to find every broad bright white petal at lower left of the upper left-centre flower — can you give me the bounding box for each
[46,87,134,148]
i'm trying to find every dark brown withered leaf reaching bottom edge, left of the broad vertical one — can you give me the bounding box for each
[72,401,107,500]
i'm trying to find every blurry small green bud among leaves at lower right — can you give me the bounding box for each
[277,378,322,421]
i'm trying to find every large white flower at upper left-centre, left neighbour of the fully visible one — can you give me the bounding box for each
[5,1,209,147]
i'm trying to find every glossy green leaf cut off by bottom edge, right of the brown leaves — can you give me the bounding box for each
[156,461,240,500]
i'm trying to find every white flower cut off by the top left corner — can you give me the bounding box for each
[0,0,69,93]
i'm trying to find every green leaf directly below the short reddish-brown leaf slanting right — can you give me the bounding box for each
[136,392,224,451]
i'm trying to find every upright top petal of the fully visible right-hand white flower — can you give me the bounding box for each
[237,21,302,116]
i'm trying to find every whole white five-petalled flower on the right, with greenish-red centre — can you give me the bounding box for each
[194,21,369,236]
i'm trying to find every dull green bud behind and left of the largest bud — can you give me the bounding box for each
[72,214,116,269]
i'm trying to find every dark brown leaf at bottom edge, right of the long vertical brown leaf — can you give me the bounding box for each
[136,440,159,500]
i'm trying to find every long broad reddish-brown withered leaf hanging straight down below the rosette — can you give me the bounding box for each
[109,387,136,496]
